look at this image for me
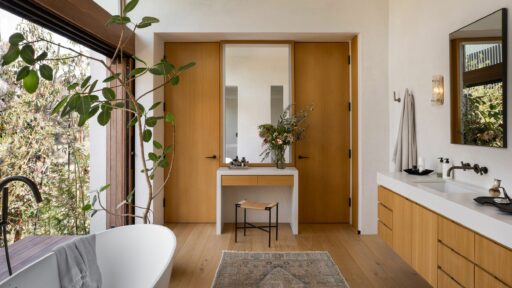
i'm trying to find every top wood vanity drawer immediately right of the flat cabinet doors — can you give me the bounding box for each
[439,217,475,261]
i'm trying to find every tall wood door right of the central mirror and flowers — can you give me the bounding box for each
[295,43,350,223]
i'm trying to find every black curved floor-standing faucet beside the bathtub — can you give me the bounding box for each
[0,176,43,276]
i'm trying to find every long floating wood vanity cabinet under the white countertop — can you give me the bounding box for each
[378,187,512,288]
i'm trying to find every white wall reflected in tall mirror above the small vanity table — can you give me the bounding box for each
[225,44,291,163]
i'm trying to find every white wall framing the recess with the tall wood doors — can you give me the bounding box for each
[115,0,389,233]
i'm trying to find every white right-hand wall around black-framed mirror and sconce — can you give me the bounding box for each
[387,0,512,190]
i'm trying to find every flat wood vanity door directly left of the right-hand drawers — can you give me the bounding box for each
[412,204,437,287]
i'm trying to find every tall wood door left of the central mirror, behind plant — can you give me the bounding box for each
[165,43,220,223]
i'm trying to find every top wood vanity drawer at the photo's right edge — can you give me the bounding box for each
[475,235,512,286]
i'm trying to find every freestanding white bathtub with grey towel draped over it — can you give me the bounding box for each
[0,224,176,288]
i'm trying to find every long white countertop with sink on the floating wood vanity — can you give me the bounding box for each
[377,172,512,249]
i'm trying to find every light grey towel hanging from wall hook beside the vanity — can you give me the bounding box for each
[393,89,418,172]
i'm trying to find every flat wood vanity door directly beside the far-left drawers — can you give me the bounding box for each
[393,194,413,265]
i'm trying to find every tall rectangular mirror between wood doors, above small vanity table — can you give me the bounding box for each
[222,43,293,164]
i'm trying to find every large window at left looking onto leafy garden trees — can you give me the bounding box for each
[0,9,105,241]
